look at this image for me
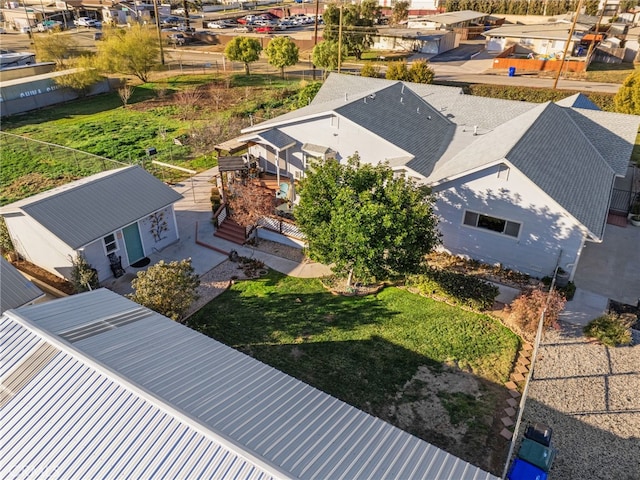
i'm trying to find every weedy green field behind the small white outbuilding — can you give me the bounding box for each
[0,75,300,204]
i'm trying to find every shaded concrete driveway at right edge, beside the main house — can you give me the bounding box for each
[574,224,640,305]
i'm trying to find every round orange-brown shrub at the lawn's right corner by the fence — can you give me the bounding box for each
[510,290,567,333]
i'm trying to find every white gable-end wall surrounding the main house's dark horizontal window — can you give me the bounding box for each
[434,167,585,278]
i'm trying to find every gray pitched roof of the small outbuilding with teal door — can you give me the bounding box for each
[0,166,182,249]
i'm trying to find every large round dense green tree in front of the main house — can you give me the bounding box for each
[296,153,439,286]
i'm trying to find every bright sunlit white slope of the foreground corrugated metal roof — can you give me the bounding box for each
[0,316,279,480]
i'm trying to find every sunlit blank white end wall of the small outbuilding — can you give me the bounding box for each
[5,215,75,277]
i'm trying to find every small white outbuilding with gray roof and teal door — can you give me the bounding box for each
[0,166,182,281]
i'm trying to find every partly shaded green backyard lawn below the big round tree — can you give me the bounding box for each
[189,272,519,412]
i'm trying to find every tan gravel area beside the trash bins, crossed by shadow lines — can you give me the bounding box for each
[521,324,640,480]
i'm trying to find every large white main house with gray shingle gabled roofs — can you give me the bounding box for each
[243,74,640,277]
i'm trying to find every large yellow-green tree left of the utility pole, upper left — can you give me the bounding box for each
[96,24,160,83]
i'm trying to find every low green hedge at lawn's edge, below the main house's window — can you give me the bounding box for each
[408,268,499,310]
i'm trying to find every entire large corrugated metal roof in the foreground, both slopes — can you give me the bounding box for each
[0,290,496,480]
